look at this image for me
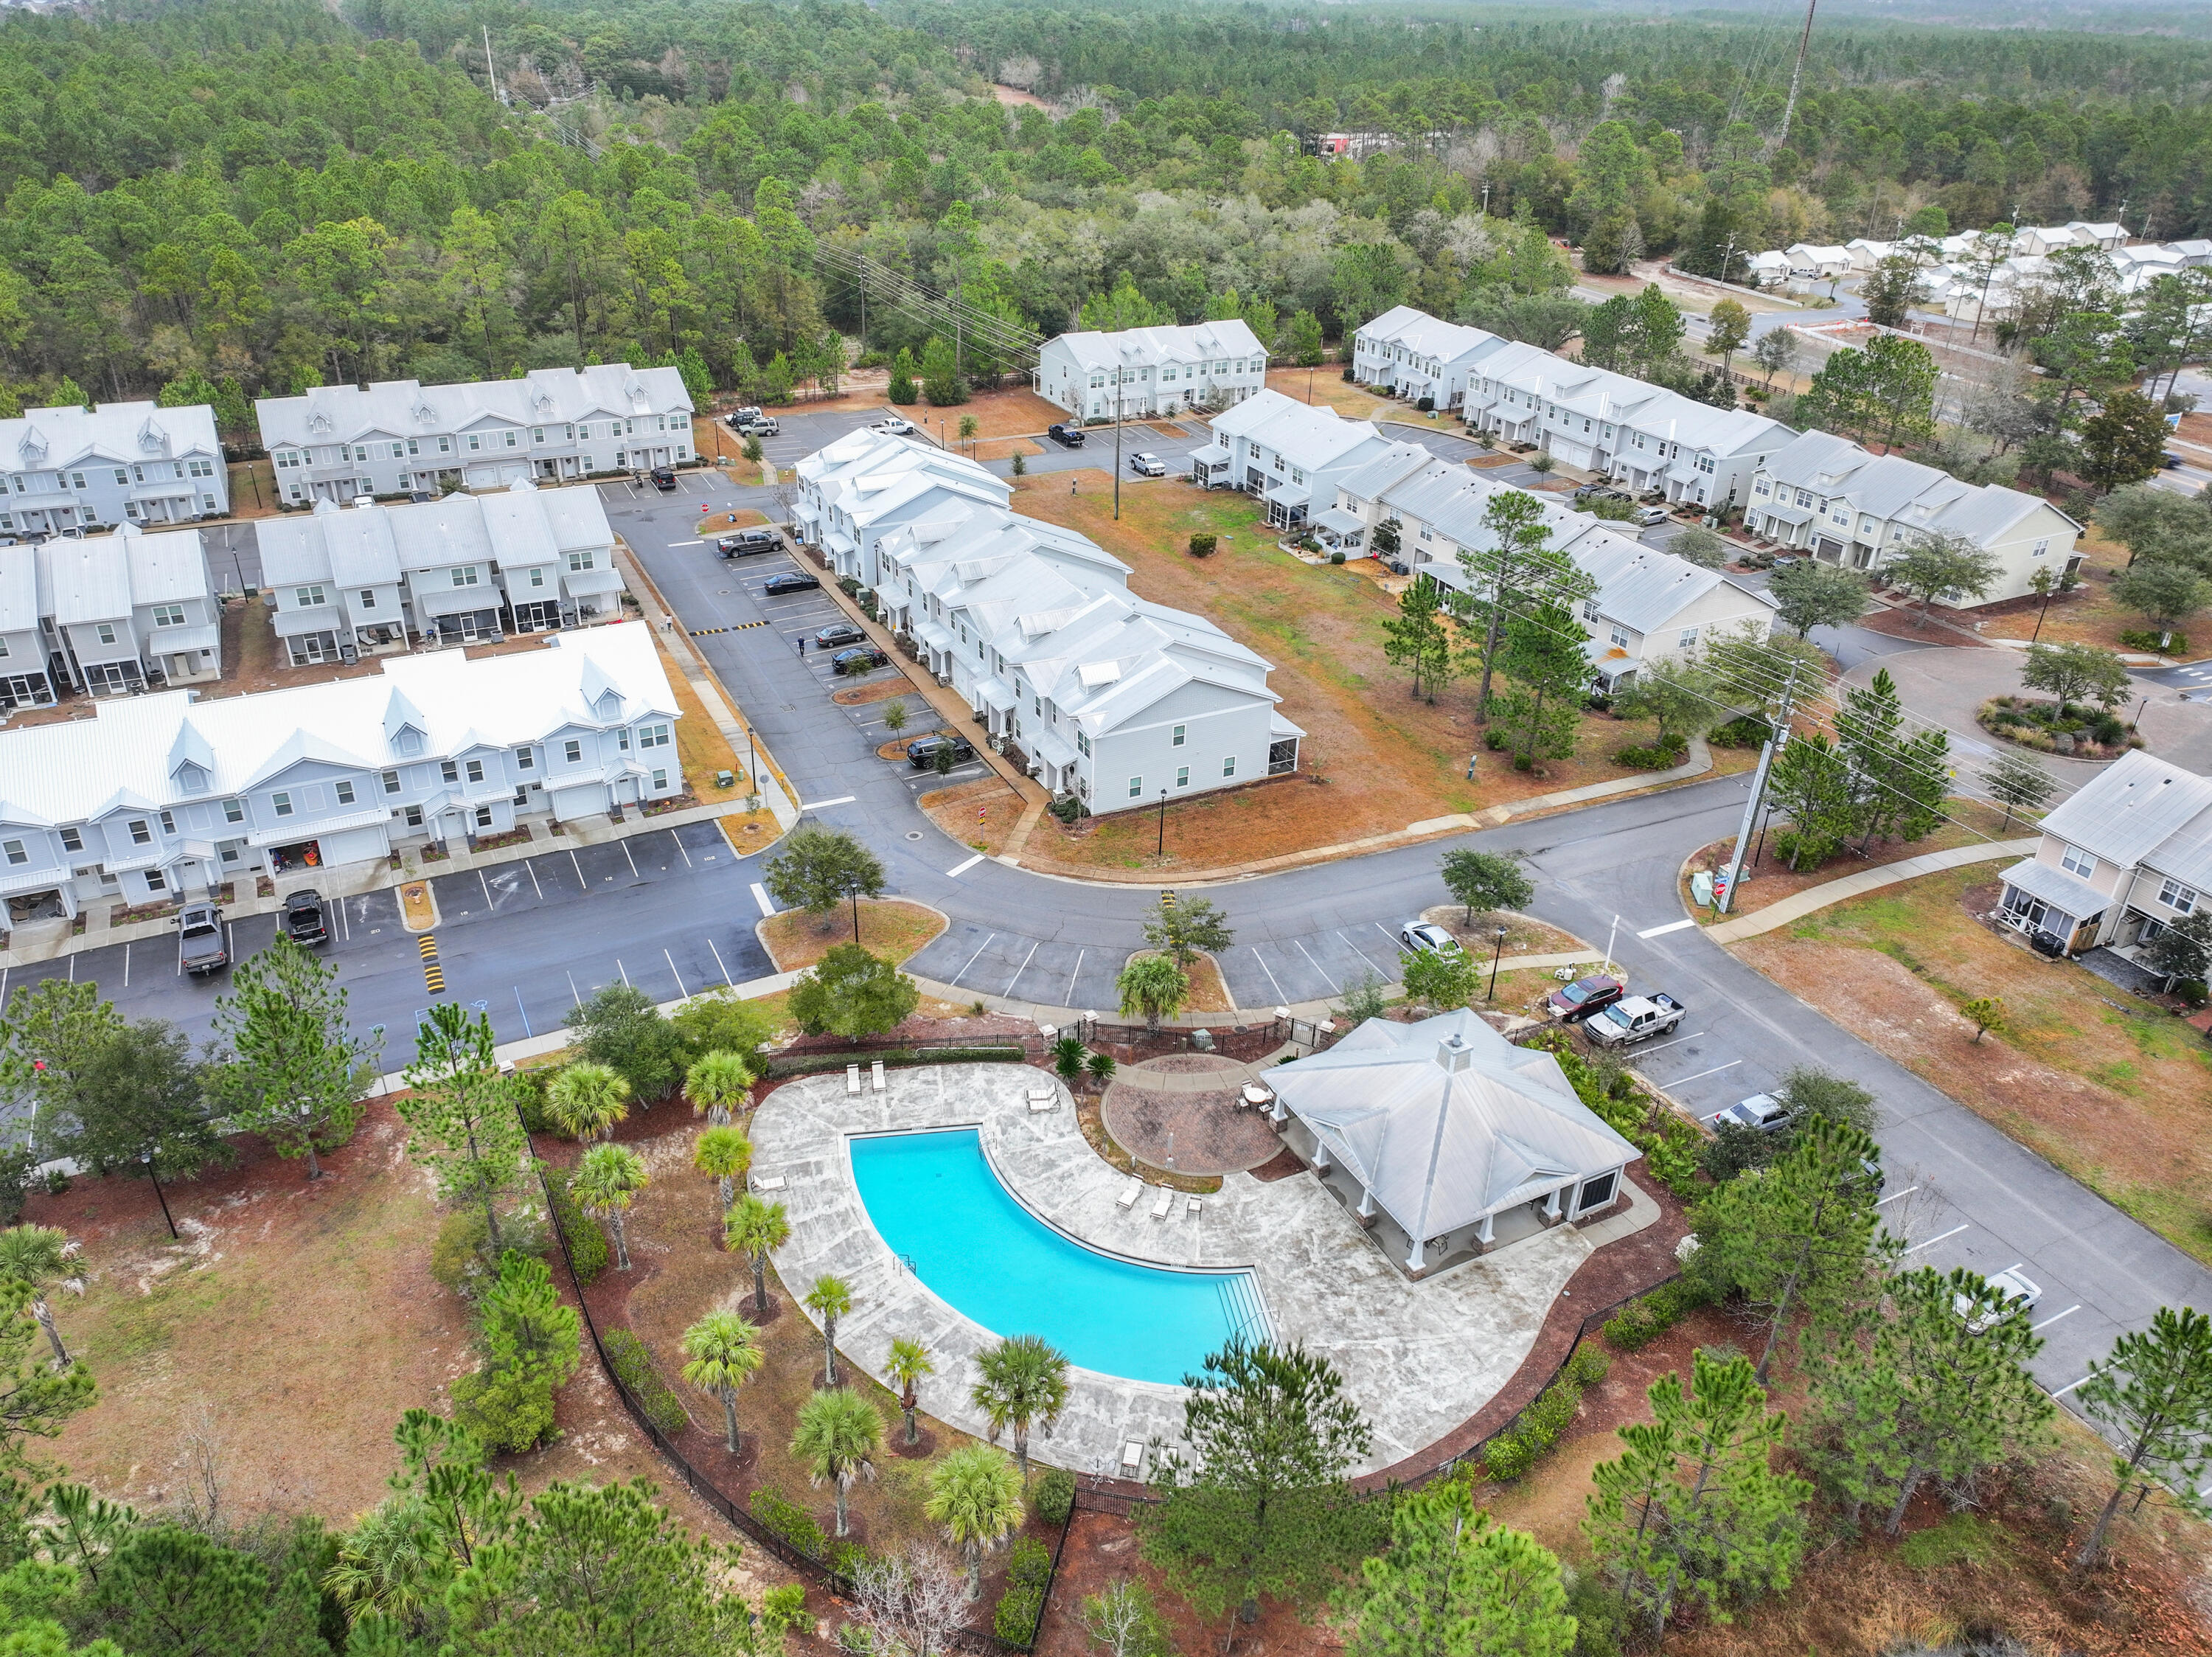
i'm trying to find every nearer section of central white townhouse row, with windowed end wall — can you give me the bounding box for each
[858,489,1305,816]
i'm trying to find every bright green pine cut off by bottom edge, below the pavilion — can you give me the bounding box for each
[1338,1480,1575,1657]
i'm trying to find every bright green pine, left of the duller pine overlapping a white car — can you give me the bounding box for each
[1582,1354,1812,1637]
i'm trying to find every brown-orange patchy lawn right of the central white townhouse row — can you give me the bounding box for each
[1013,471,1681,872]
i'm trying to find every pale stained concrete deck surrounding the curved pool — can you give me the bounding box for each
[752,1064,1601,1473]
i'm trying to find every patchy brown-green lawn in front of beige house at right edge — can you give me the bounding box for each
[1736,865,2212,1261]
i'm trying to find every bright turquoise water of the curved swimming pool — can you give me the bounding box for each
[852,1128,1259,1387]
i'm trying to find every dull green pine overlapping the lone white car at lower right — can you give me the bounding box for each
[1812,1268,2055,1535]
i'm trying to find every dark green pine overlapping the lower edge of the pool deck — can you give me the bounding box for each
[1137,1336,1374,1622]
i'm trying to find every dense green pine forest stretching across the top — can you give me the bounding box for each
[0,0,2212,427]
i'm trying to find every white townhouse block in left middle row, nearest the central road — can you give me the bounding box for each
[257,482,622,668]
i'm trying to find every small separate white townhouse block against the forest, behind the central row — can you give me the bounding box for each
[1033,316,1267,423]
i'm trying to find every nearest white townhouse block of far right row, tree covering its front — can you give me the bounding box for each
[1743,431,2081,608]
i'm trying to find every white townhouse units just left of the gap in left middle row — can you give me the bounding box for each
[33,522,223,697]
